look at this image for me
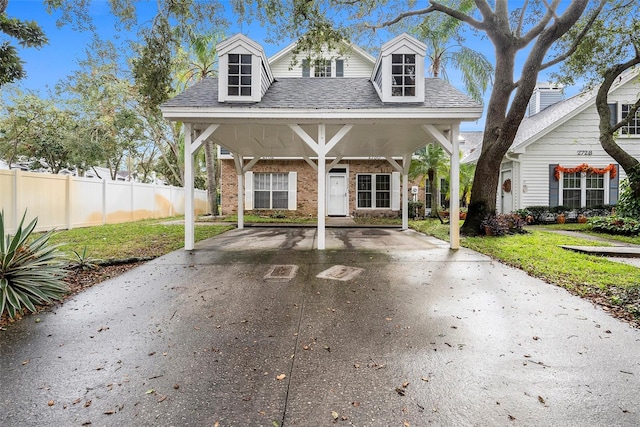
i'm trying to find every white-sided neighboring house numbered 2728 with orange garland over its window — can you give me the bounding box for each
[463,68,640,217]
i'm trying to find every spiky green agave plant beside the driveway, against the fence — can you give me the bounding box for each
[0,212,67,319]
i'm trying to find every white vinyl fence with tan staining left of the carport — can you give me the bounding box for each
[0,170,208,233]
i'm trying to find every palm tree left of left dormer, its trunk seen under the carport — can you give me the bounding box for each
[178,33,221,215]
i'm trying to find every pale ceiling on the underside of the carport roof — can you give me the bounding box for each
[198,120,448,158]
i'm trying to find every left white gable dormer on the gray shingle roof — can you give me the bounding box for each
[217,34,273,102]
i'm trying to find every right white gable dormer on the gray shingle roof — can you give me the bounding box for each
[371,33,427,102]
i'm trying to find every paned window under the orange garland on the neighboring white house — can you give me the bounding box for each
[560,172,609,209]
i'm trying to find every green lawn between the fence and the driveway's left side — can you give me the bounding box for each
[45,218,233,260]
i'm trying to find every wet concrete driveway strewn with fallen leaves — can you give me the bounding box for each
[0,228,640,426]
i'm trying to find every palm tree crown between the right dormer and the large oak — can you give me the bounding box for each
[412,0,493,102]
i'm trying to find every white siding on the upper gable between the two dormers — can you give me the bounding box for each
[269,50,373,78]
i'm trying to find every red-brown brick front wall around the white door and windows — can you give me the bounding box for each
[220,159,425,216]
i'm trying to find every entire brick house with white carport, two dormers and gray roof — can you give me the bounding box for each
[161,34,482,249]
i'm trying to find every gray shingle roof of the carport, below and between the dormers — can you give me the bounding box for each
[162,78,482,110]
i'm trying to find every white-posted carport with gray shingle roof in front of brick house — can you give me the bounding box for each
[162,78,482,250]
